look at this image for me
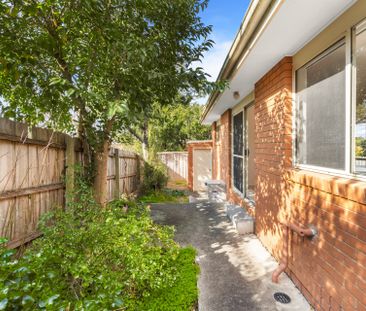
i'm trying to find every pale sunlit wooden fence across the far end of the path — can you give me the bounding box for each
[158,151,188,182]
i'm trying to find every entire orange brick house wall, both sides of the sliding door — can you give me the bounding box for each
[213,57,366,310]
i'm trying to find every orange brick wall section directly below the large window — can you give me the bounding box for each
[285,170,366,310]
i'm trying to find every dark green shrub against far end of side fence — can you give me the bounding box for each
[141,162,168,193]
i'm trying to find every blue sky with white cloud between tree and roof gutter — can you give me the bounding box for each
[197,0,250,104]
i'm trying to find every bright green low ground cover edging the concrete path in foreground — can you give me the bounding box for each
[138,247,199,311]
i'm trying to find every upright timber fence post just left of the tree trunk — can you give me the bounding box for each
[65,135,75,207]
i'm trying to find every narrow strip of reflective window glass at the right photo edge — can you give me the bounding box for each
[353,25,366,174]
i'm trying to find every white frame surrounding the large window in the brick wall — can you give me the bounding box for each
[292,19,366,181]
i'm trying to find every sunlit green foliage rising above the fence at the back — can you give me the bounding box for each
[149,103,211,152]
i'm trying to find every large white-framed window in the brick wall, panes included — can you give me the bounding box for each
[296,21,366,175]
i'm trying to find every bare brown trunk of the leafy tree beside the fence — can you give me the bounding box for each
[94,139,111,207]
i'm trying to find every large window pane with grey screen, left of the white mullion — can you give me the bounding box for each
[296,44,346,169]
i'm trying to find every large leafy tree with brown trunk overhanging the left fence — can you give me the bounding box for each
[0,0,217,204]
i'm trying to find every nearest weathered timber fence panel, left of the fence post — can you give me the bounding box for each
[0,118,66,247]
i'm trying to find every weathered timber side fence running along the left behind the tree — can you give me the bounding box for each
[0,118,139,248]
